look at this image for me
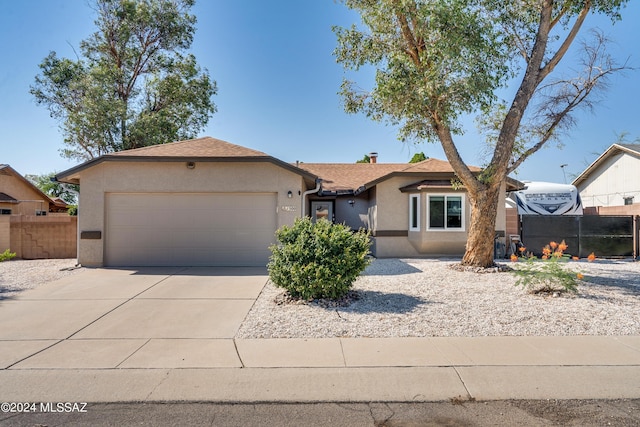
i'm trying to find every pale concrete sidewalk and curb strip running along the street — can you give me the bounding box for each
[0,337,640,402]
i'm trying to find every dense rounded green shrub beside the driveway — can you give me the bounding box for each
[268,218,371,299]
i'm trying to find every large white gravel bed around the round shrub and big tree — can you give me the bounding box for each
[236,259,640,338]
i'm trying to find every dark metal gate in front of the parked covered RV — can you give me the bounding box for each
[521,215,638,257]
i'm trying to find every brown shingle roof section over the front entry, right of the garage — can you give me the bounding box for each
[299,159,480,193]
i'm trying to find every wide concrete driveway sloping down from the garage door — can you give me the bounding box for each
[0,267,267,369]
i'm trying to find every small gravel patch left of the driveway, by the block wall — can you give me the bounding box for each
[0,258,82,300]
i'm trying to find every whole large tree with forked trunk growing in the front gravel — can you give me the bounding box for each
[334,0,628,266]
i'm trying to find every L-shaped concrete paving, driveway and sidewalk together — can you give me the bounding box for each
[0,268,640,402]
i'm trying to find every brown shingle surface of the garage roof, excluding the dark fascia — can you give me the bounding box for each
[109,136,268,158]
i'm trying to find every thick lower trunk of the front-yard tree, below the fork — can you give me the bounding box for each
[462,185,501,268]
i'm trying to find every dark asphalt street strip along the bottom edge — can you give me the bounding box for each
[0,399,640,427]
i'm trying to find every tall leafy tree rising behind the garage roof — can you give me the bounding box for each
[30,0,217,160]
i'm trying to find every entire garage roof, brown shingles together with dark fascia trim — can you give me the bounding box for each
[55,136,317,184]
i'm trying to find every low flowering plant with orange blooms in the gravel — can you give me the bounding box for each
[511,240,596,294]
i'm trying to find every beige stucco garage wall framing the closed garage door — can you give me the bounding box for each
[78,162,305,266]
